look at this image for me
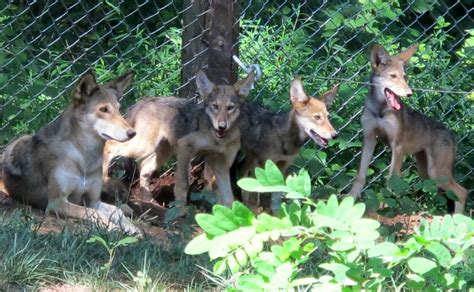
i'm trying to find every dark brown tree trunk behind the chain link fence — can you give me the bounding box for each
[180,0,240,98]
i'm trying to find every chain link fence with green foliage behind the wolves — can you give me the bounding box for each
[0,0,474,206]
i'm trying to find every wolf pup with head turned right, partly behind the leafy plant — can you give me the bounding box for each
[205,79,339,212]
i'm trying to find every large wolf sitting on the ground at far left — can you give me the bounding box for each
[3,73,140,233]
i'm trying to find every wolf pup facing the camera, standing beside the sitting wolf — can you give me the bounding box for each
[103,71,254,205]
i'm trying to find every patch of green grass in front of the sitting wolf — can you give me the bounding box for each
[0,210,212,291]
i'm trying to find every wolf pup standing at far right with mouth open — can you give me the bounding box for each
[350,45,467,213]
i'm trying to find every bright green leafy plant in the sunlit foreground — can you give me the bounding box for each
[185,161,474,290]
